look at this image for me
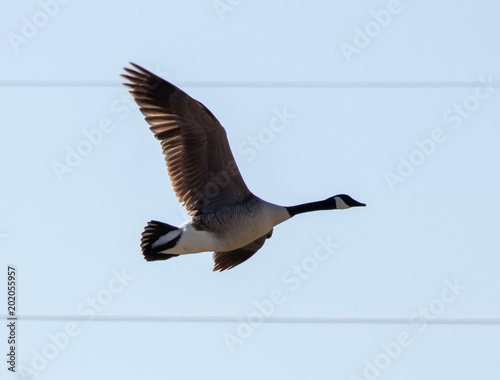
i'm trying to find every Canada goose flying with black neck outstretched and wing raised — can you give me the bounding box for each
[122,63,365,271]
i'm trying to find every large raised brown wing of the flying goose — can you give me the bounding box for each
[122,63,251,215]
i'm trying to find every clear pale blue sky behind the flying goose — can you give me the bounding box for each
[0,0,500,380]
